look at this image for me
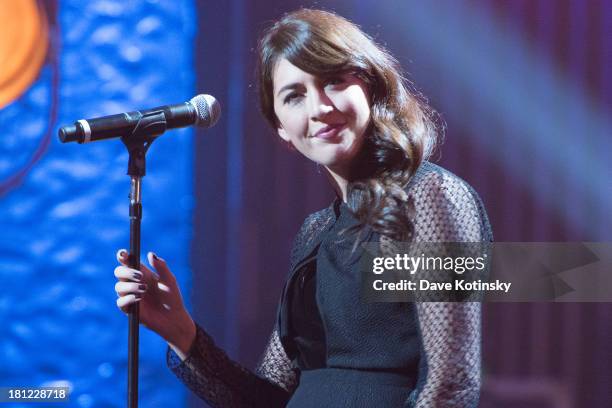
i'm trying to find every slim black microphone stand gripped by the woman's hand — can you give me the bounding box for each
[121,111,166,408]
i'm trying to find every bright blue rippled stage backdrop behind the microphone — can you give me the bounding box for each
[0,0,196,407]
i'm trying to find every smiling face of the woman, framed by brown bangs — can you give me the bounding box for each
[272,59,370,173]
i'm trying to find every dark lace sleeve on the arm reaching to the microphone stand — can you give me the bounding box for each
[167,326,295,408]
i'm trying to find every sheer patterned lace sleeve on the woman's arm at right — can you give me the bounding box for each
[406,165,492,408]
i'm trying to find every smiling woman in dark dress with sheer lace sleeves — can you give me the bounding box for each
[115,9,491,407]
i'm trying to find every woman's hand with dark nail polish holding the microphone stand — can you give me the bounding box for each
[115,249,196,356]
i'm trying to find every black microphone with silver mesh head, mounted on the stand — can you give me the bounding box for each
[58,94,221,143]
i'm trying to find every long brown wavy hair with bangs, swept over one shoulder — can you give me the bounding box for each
[258,9,438,240]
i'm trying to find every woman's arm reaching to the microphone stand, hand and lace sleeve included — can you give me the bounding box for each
[115,250,293,407]
